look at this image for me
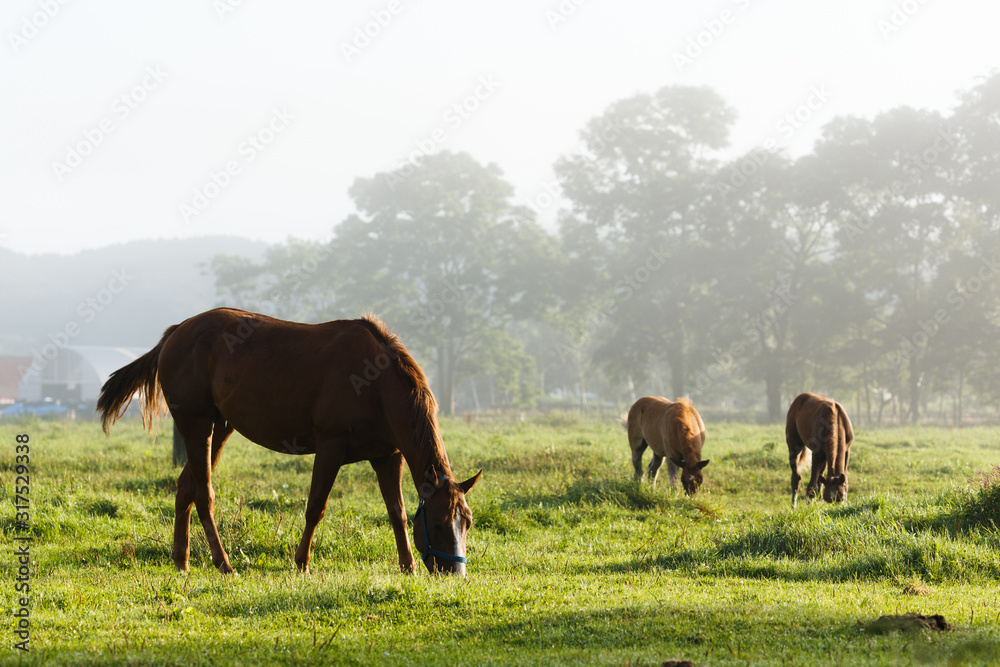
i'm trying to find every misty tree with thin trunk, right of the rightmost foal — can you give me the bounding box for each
[816,107,962,422]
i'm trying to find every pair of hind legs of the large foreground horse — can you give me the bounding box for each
[171,417,233,574]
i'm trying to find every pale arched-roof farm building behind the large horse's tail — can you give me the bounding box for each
[17,345,149,406]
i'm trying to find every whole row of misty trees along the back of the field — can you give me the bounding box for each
[213,75,1000,421]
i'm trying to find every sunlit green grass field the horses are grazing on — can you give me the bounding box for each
[0,413,1000,666]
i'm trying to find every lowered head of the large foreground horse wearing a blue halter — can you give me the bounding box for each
[413,470,483,576]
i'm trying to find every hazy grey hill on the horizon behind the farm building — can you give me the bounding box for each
[0,236,267,355]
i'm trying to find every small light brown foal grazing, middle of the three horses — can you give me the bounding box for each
[627,396,708,496]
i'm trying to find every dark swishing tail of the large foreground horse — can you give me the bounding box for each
[97,325,177,435]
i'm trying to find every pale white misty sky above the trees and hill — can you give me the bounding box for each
[0,0,1000,253]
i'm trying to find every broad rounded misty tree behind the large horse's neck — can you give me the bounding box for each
[326,152,559,414]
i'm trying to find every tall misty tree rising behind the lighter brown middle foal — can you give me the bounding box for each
[556,86,735,396]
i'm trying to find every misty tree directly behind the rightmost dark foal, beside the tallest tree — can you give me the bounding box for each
[695,150,841,421]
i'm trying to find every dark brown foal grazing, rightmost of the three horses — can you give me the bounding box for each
[785,393,854,507]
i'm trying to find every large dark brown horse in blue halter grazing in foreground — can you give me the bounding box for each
[97,308,482,575]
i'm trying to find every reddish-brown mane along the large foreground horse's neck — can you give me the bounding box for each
[357,313,457,517]
